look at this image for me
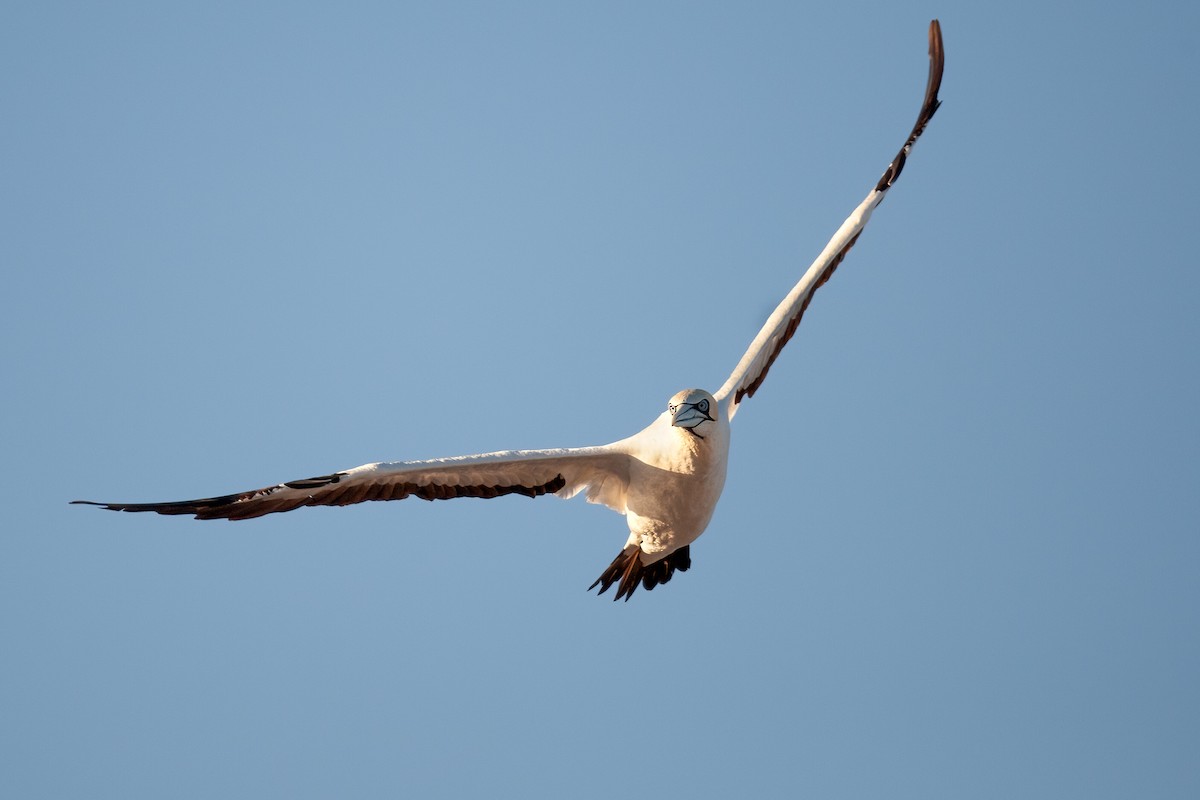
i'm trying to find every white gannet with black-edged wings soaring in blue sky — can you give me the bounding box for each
[72,19,944,602]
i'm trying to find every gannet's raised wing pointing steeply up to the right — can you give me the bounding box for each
[715,19,946,419]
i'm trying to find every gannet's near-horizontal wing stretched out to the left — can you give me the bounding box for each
[74,446,629,519]
